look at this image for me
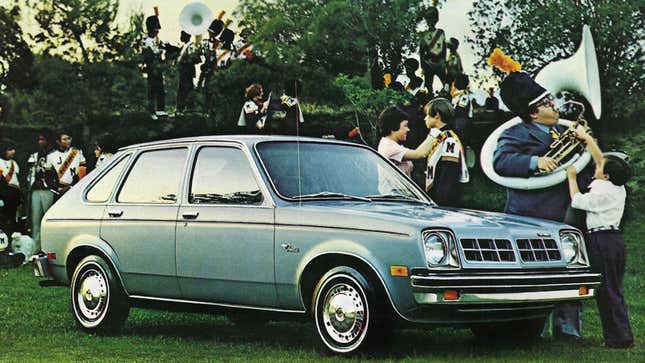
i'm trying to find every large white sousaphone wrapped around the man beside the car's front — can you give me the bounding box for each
[480,25,601,190]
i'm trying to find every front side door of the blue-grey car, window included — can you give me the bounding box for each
[177,144,276,306]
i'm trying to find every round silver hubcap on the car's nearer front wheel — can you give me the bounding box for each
[322,283,365,344]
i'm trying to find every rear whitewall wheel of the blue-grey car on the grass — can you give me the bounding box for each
[71,255,130,334]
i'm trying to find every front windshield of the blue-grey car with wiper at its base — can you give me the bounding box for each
[257,142,429,203]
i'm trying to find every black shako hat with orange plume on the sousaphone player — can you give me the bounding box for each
[488,48,549,115]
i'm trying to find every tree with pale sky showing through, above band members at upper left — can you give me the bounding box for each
[32,0,143,64]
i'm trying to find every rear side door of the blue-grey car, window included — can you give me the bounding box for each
[101,146,189,298]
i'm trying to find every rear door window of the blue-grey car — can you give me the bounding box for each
[117,148,188,204]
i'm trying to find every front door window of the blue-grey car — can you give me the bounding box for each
[188,147,262,204]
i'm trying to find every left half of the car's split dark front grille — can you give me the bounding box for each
[461,238,515,262]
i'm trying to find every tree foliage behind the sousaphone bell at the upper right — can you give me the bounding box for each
[468,0,645,131]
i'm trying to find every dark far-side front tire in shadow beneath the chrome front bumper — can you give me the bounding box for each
[470,318,546,342]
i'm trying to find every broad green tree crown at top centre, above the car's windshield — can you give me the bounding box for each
[238,0,424,98]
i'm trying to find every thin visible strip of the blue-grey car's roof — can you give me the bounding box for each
[119,135,359,151]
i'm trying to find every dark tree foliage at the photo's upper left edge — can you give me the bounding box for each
[0,3,33,88]
